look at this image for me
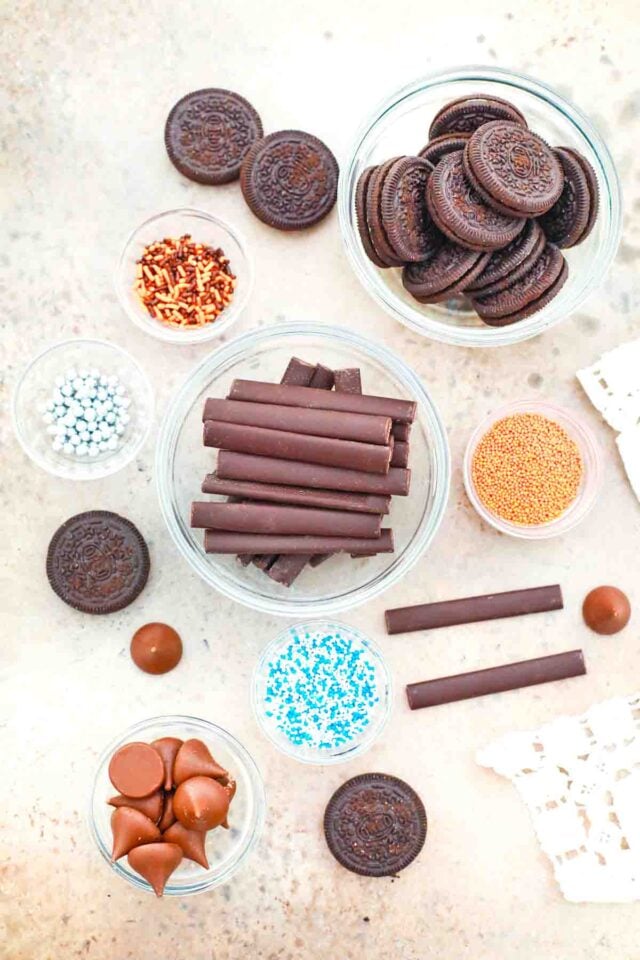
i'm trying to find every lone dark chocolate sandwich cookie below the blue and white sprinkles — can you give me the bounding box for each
[324,773,427,877]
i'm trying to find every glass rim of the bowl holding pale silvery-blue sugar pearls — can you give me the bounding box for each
[11,337,155,483]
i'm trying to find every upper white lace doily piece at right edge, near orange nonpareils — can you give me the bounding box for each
[576,340,640,500]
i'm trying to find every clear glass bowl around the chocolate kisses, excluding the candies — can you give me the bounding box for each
[89,716,266,897]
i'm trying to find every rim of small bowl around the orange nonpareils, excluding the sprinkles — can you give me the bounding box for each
[462,400,602,540]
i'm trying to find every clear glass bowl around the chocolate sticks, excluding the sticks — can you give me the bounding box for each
[156,323,450,619]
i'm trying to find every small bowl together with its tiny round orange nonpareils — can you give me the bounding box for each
[463,400,601,540]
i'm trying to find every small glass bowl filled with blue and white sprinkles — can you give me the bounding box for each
[252,620,391,764]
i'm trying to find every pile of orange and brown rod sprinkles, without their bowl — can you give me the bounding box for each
[134,233,236,327]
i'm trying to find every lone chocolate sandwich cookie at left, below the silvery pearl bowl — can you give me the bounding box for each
[47,510,150,613]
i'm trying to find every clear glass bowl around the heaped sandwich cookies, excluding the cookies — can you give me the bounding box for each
[338,67,622,347]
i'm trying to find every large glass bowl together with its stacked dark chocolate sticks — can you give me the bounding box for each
[156,323,450,617]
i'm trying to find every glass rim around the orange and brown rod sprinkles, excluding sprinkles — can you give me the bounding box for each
[113,207,254,346]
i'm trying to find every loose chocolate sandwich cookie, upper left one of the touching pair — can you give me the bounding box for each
[164,88,262,184]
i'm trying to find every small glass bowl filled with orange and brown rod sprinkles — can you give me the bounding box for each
[115,209,253,343]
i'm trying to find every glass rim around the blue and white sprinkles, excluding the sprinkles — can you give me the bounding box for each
[251,617,394,767]
